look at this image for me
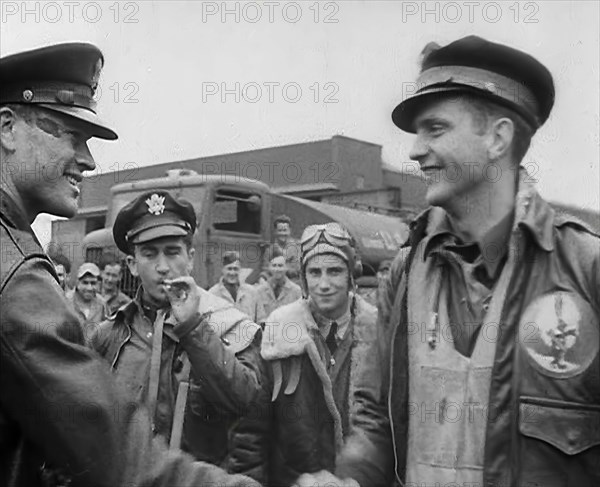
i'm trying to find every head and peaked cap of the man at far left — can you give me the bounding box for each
[0,43,117,222]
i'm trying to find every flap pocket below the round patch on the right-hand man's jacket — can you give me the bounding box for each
[519,397,600,455]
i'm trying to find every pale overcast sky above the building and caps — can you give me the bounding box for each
[0,0,600,248]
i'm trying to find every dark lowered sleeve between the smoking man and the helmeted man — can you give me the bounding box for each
[223,332,271,484]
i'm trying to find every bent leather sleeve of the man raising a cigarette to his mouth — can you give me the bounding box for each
[173,312,261,414]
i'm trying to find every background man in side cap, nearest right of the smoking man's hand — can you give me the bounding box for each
[209,250,257,322]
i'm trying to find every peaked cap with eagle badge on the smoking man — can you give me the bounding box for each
[113,191,196,254]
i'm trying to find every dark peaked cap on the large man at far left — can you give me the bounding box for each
[0,42,117,140]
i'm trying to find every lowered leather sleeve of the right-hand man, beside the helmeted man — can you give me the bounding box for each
[336,249,406,487]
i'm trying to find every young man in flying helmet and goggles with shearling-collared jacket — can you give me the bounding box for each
[261,223,377,486]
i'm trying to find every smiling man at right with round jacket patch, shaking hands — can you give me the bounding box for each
[300,36,600,487]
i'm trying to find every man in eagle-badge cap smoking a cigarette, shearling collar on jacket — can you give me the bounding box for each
[91,191,268,480]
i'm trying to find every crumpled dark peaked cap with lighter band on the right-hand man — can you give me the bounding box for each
[392,36,555,132]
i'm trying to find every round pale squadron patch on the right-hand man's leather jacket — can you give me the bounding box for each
[519,291,599,378]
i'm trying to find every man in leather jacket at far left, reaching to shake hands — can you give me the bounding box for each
[0,43,255,487]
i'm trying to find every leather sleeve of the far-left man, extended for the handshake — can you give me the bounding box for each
[0,259,256,487]
